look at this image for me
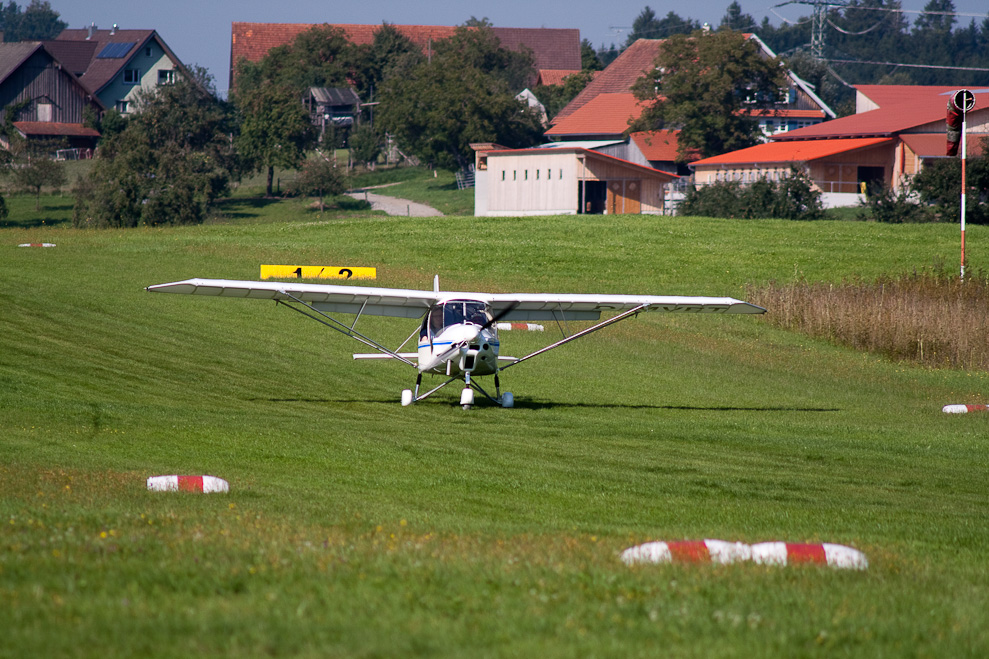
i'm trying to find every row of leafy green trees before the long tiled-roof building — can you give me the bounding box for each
[74,21,543,226]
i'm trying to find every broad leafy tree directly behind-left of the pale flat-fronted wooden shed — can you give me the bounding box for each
[376,27,542,170]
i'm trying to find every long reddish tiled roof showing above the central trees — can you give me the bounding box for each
[230,22,581,91]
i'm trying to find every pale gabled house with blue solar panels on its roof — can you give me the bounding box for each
[52,26,188,115]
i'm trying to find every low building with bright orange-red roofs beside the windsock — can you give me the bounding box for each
[690,85,989,206]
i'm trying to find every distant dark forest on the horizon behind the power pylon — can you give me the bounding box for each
[597,0,989,115]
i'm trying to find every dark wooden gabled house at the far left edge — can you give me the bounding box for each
[0,41,105,149]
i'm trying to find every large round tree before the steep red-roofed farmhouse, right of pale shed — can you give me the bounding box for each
[632,30,787,158]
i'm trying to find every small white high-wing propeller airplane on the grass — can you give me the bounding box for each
[147,276,766,410]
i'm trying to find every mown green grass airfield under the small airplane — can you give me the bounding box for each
[0,214,989,657]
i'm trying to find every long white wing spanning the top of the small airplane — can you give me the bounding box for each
[147,279,766,321]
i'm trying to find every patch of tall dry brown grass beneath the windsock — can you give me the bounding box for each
[749,269,989,370]
